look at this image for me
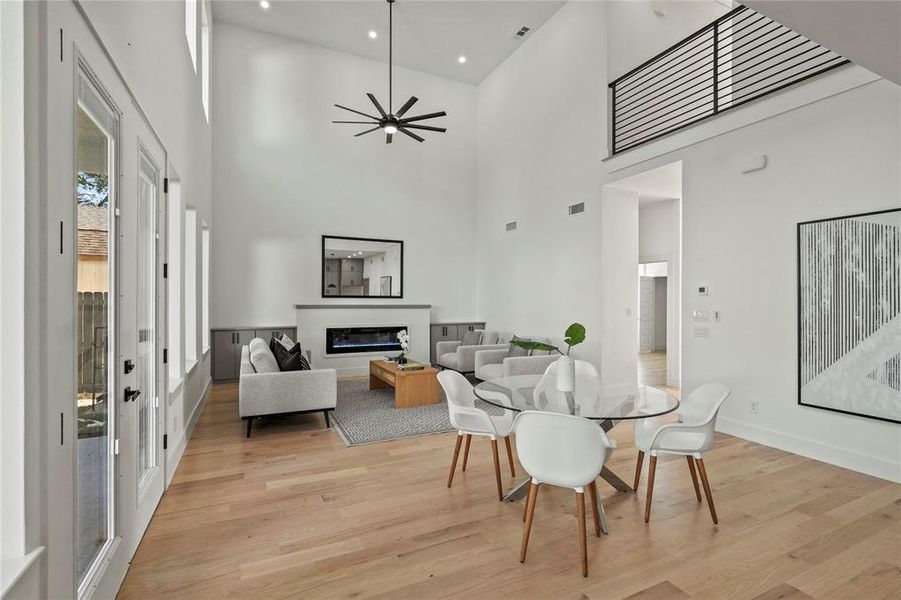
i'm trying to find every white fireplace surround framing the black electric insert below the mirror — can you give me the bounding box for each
[294,303,432,376]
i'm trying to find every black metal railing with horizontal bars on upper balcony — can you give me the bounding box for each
[610,6,849,154]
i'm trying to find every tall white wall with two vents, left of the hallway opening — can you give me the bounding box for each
[476,2,608,364]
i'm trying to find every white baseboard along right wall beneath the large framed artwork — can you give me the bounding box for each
[716,417,901,483]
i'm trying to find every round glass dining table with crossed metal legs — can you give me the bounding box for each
[474,374,679,501]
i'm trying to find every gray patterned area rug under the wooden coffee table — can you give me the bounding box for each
[332,379,453,446]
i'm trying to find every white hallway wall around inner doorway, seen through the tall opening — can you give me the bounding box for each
[638,197,682,387]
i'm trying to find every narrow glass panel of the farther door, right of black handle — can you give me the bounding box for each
[137,150,159,483]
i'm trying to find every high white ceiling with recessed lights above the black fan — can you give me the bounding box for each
[213,0,564,84]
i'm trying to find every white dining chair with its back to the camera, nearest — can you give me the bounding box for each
[514,411,613,577]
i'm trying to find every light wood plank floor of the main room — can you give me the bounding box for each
[120,385,901,600]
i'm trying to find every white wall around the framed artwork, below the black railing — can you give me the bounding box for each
[612,81,901,481]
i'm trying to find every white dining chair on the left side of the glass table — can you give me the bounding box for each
[438,370,516,500]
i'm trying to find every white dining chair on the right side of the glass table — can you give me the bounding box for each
[633,383,732,525]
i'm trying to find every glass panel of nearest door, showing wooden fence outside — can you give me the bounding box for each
[75,89,116,584]
